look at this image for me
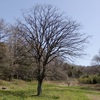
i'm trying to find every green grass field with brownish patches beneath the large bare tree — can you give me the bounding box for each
[0,80,100,100]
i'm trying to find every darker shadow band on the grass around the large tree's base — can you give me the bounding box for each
[0,90,60,100]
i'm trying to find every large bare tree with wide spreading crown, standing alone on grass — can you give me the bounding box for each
[13,5,87,95]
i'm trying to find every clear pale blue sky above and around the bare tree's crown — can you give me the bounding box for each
[0,0,100,66]
